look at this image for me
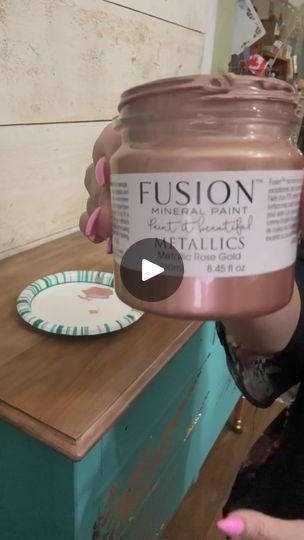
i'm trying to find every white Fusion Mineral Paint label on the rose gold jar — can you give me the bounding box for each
[111,170,303,278]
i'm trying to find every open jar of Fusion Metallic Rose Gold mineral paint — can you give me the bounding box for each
[111,74,303,319]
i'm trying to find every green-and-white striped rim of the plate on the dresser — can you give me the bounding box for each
[17,270,143,336]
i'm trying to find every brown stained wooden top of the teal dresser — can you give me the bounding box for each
[0,233,202,461]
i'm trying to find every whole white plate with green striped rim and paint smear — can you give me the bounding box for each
[17,270,143,336]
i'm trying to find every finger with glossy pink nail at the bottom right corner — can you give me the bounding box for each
[217,510,304,540]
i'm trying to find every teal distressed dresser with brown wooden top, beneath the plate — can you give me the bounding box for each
[0,234,239,540]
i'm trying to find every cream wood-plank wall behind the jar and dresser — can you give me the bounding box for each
[0,0,208,257]
